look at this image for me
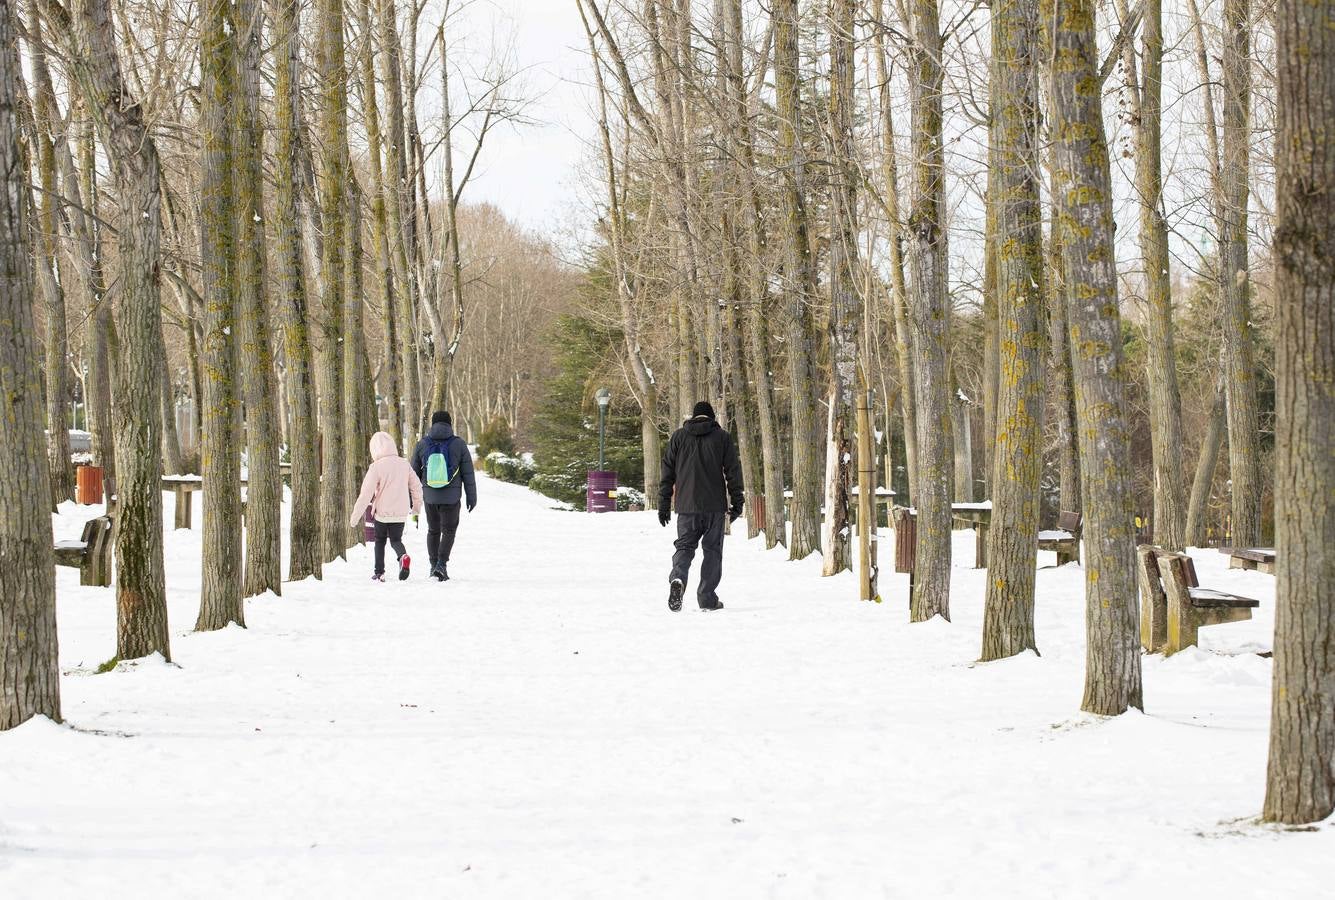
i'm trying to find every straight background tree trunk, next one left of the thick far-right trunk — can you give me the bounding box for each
[1219,0,1263,547]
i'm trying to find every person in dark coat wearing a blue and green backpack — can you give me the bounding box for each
[413,413,478,581]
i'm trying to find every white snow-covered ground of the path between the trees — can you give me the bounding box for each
[0,479,1335,900]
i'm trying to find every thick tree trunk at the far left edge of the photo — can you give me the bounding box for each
[0,3,60,730]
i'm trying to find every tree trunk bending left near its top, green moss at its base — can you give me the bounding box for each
[63,0,171,660]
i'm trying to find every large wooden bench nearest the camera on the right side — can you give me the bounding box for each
[1136,545,1260,654]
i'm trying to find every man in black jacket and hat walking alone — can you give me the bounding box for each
[658,401,744,613]
